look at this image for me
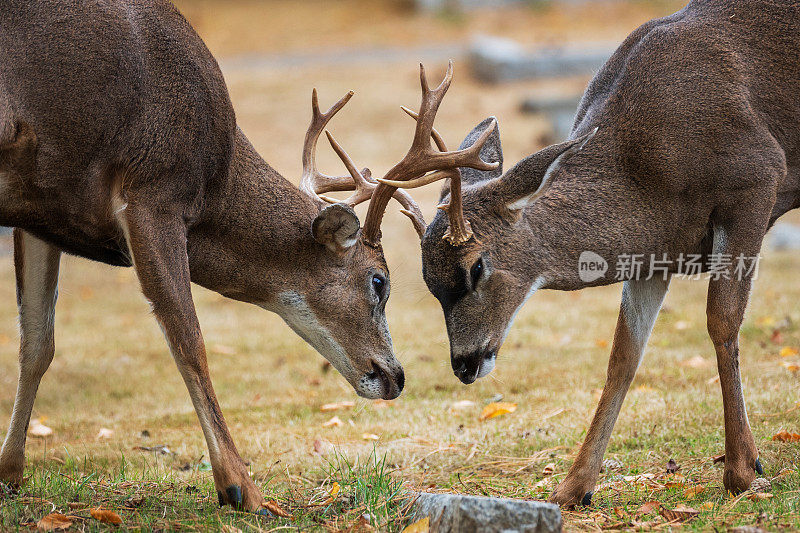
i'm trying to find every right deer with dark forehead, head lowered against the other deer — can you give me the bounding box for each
[383,0,800,505]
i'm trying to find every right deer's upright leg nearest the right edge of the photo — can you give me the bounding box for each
[706,223,763,494]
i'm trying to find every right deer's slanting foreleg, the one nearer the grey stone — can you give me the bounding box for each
[550,278,669,506]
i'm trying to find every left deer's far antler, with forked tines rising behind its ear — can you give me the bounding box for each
[300,89,425,237]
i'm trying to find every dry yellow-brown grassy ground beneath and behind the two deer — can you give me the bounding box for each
[0,1,800,531]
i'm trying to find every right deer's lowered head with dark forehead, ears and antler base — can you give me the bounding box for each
[390,88,596,384]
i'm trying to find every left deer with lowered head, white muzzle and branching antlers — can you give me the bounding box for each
[0,0,492,514]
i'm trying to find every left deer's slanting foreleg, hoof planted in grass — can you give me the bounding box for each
[118,203,266,512]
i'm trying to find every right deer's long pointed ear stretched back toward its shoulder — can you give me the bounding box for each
[490,128,599,212]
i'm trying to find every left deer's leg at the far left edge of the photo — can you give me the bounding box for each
[0,229,61,487]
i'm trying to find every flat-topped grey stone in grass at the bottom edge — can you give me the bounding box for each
[412,492,561,533]
